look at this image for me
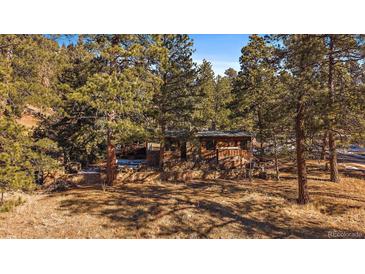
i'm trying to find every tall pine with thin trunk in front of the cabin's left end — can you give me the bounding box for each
[152,34,197,169]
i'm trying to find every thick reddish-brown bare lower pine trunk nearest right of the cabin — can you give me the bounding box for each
[295,97,309,204]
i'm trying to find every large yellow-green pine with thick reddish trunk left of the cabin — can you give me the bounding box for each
[71,35,160,185]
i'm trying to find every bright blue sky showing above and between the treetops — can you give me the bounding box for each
[59,34,249,75]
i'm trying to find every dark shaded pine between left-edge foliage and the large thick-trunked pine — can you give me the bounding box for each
[37,40,105,167]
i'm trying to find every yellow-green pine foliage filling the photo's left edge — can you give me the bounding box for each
[0,35,61,199]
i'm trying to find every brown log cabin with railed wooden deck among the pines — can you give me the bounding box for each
[147,131,253,169]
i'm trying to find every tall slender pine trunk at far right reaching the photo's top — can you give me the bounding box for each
[328,35,339,183]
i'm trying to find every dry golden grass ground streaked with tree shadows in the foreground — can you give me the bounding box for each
[0,161,365,238]
